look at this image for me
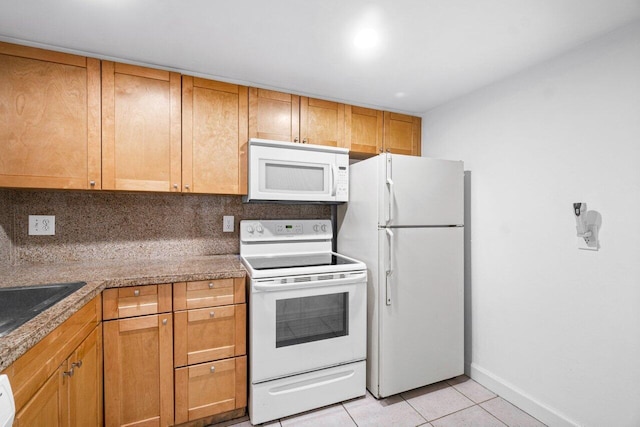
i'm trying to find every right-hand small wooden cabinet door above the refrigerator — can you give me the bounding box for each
[384,111,422,156]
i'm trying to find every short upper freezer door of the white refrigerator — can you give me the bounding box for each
[378,154,464,227]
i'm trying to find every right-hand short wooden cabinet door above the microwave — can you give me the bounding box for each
[300,96,344,147]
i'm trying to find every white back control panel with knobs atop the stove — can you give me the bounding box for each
[240,219,333,242]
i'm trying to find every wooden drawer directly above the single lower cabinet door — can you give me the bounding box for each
[102,283,171,320]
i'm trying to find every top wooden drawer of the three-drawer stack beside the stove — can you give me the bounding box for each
[173,277,245,310]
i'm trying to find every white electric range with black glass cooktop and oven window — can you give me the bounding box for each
[240,220,367,424]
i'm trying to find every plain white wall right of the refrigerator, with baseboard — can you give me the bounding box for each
[422,22,640,426]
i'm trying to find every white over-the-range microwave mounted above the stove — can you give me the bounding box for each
[243,138,349,203]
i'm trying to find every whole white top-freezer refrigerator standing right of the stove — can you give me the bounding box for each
[338,154,464,398]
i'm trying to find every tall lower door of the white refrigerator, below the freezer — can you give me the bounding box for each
[378,227,464,397]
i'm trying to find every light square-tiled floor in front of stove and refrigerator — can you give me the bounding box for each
[215,375,544,427]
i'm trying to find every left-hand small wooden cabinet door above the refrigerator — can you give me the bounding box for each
[344,105,384,158]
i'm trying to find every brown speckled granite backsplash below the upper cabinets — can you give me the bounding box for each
[0,189,331,266]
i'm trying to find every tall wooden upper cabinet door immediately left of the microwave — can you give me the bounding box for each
[182,76,249,194]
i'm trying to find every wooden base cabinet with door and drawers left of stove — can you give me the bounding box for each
[103,277,247,427]
